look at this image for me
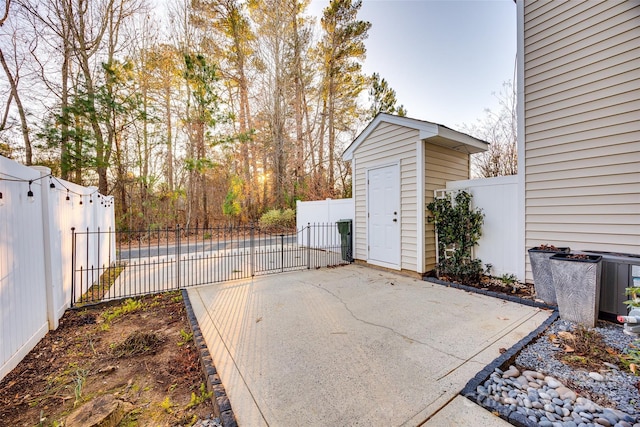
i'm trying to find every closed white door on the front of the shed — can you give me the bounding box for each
[367,165,400,268]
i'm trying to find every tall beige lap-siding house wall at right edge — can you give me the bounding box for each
[524,0,640,280]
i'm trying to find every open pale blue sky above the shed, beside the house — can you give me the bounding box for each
[308,0,516,129]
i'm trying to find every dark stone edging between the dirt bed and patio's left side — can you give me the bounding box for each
[182,289,238,427]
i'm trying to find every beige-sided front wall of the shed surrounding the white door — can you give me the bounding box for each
[353,122,419,271]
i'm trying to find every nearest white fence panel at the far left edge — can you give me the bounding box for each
[0,157,49,378]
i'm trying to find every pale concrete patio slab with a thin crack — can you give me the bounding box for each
[188,265,551,426]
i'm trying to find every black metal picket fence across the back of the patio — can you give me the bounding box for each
[71,224,351,306]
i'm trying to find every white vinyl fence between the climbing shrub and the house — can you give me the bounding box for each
[446,175,524,280]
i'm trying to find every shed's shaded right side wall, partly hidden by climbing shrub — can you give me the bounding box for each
[424,142,470,271]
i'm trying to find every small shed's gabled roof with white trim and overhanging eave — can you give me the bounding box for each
[342,113,489,160]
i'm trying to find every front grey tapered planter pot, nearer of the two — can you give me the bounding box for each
[550,254,602,328]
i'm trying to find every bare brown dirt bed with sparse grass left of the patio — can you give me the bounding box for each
[0,292,213,427]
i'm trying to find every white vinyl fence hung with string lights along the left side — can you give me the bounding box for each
[0,156,115,379]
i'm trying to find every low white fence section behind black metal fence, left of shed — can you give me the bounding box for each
[296,199,355,248]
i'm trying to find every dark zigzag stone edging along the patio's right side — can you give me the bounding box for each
[424,277,559,427]
